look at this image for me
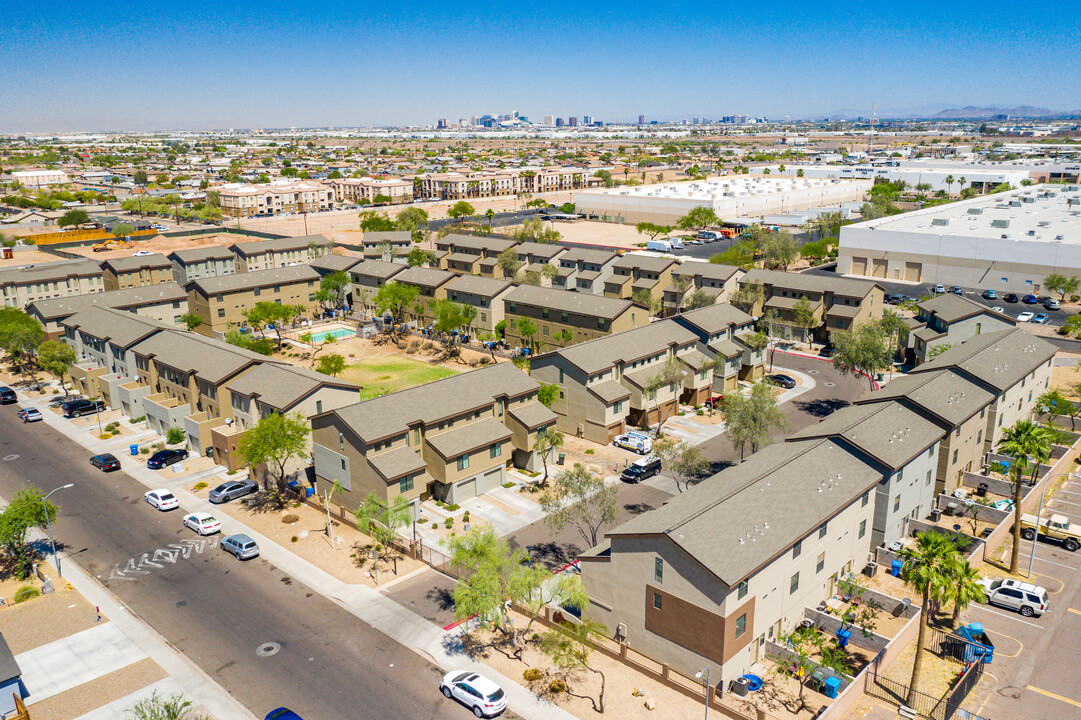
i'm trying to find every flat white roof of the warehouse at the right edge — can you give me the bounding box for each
[842,185,1081,244]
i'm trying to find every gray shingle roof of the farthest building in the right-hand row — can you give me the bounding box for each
[912,328,1056,392]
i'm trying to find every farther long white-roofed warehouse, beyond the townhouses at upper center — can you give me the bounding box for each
[574,175,871,225]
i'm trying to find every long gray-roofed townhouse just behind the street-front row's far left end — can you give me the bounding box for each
[26,282,188,339]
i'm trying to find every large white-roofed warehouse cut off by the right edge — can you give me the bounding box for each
[837,185,1081,293]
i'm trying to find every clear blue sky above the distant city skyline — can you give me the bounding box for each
[0,0,1081,132]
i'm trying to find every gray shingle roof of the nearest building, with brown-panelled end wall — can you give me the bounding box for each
[606,440,882,587]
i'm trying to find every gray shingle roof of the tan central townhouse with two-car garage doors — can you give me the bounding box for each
[334,362,541,442]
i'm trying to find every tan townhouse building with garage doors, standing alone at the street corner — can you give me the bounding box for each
[311,363,556,510]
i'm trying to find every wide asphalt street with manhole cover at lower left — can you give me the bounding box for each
[0,405,495,720]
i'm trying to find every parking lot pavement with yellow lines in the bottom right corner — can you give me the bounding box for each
[963,478,1081,720]
